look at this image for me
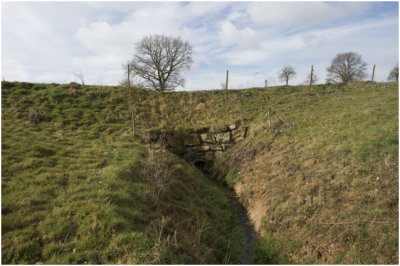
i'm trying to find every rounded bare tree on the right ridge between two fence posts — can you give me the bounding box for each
[326,52,367,83]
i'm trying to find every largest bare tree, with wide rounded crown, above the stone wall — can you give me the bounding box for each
[130,35,193,91]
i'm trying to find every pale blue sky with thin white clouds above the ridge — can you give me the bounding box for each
[1,1,399,90]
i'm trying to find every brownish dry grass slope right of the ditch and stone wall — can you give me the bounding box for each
[217,83,398,264]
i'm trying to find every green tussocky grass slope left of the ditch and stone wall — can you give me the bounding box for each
[1,82,243,264]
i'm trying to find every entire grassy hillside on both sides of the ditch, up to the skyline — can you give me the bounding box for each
[2,82,398,264]
